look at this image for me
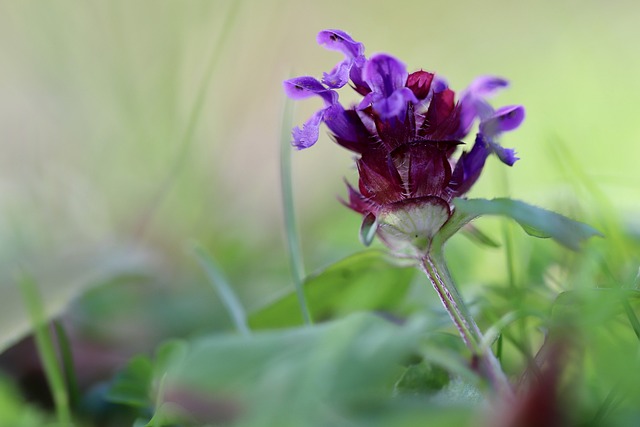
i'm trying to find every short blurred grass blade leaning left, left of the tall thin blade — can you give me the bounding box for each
[193,245,251,336]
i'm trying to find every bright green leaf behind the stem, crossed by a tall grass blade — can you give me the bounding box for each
[249,250,414,328]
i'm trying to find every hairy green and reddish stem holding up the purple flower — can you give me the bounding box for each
[420,249,514,402]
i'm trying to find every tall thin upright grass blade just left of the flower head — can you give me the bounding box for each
[280,98,311,325]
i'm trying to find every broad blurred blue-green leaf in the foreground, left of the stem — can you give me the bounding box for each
[167,313,425,426]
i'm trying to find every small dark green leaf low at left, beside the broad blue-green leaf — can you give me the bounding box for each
[106,356,153,407]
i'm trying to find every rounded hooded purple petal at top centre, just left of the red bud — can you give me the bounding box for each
[362,54,409,98]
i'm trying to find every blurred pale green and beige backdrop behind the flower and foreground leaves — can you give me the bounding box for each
[0,0,640,370]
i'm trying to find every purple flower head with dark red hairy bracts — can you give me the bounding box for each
[284,30,524,258]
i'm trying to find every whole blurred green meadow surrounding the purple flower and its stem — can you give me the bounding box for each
[0,0,640,427]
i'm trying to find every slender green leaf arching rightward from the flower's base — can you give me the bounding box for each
[437,198,601,250]
